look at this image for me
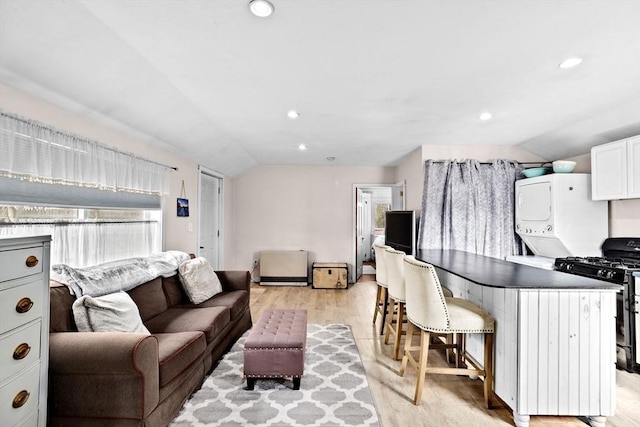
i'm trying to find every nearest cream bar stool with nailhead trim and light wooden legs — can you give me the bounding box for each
[399,256,495,408]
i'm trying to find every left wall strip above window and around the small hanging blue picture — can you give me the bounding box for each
[0,84,198,252]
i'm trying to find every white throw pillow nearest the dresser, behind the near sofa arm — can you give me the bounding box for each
[72,291,150,334]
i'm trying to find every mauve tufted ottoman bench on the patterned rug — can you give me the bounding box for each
[244,309,307,390]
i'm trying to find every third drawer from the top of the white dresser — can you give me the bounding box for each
[0,321,42,383]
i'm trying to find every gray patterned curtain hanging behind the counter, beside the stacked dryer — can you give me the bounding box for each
[418,160,524,258]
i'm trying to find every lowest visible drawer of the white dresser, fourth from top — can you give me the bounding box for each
[0,363,40,426]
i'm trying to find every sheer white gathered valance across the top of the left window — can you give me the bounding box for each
[0,113,169,194]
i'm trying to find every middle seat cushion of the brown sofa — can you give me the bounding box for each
[146,307,231,344]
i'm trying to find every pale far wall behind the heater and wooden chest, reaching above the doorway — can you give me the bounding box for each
[226,166,394,270]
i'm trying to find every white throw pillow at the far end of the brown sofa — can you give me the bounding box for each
[178,257,222,304]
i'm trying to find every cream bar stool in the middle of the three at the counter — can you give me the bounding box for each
[384,248,405,360]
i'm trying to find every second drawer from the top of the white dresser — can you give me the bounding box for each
[0,280,43,334]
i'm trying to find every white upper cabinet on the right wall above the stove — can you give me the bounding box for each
[591,135,640,200]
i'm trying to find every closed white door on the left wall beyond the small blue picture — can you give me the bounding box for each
[198,170,222,270]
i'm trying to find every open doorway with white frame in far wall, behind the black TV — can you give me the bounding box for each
[350,181,405,283]
